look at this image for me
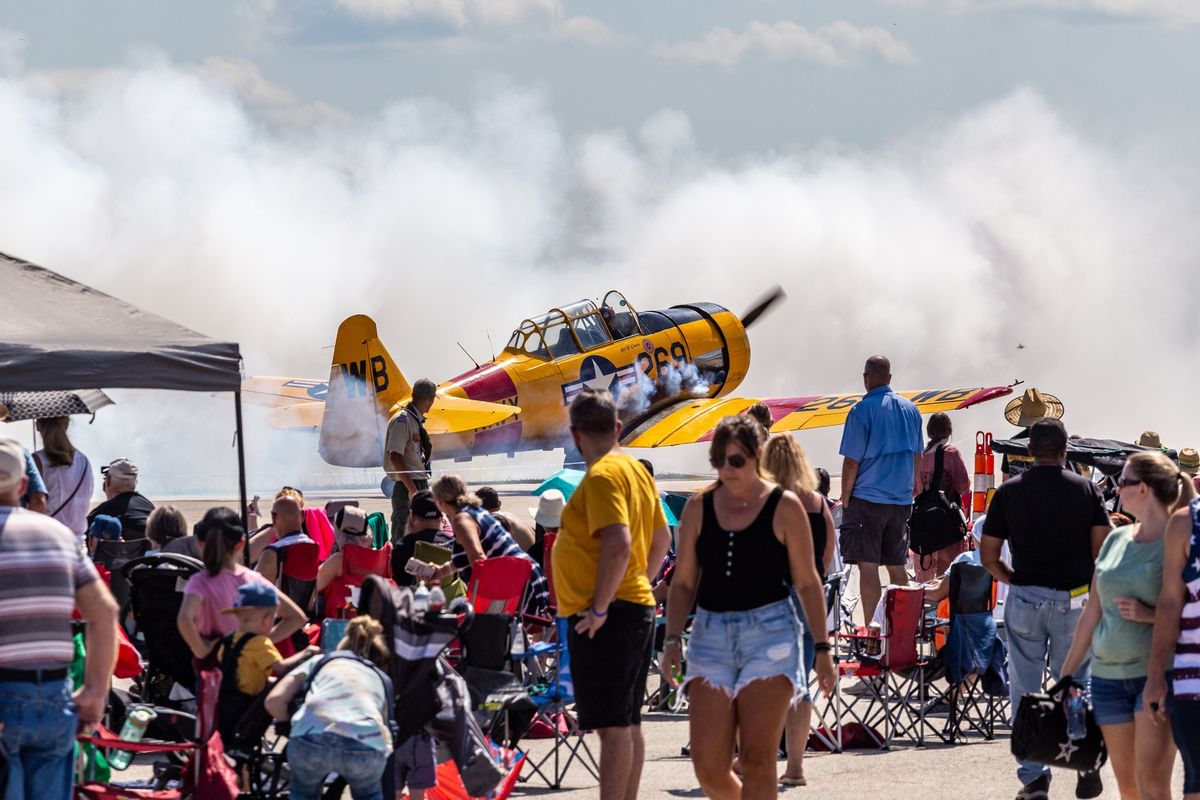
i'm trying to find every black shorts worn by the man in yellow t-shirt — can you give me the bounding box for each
[566,600,654,730]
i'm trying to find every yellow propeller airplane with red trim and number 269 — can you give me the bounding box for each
[242,288,1012,467]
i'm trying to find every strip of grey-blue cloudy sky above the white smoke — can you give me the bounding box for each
[9,0,1200,151]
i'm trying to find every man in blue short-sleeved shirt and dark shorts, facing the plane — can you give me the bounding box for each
[841,355,925,614]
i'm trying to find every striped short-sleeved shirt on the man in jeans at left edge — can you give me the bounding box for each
[0,506,100,669]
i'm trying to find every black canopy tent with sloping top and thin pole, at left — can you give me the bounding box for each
[0,253,246,524]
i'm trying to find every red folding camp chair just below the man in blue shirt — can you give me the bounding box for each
[838,587,929,750]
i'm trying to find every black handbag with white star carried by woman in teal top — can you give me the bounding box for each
[1013,678,1109,772]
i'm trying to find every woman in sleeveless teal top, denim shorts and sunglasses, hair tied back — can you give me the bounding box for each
[1062,452,1194,800]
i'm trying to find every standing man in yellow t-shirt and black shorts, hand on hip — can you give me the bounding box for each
[551,390,670,800]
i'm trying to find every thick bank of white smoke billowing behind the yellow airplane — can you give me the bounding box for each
[0,42,1200,494]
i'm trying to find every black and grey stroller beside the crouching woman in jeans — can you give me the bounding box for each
[359,576,521,800]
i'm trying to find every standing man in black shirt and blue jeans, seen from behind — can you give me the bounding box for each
[980,420,1110,800]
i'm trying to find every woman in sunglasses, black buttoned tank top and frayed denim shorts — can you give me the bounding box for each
[662,416,834,798]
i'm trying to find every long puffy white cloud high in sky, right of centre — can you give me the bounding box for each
[653,19,917,67]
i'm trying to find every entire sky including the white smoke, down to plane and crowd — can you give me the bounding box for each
[0,0,1200,482]
